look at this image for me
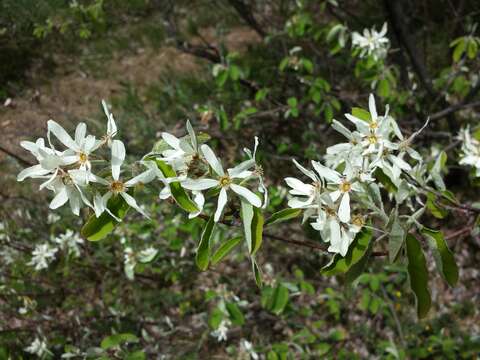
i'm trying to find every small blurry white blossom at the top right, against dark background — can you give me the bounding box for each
[352,23,390,60]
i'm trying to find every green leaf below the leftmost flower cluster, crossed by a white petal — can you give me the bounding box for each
[81,195,130,241]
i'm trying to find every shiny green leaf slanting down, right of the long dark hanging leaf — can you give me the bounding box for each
[421,227,458,287]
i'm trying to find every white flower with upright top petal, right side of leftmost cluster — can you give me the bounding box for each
[90,140,158,221]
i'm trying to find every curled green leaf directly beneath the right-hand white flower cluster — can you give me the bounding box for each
[321,227,372,275]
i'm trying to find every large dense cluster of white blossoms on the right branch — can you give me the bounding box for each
[285,95,430,256]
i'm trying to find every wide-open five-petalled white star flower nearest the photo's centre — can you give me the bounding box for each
[182,144,262,222]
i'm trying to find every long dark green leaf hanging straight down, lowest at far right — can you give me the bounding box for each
[406,234,432,318]
